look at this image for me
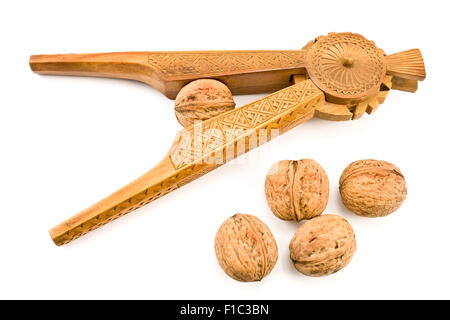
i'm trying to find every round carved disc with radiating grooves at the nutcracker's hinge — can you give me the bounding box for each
[306,33,386,99]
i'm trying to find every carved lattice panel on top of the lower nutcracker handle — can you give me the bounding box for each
[170,80,324,169]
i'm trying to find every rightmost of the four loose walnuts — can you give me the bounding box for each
[339,159,407,217]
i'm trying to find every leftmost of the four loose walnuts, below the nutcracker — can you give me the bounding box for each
[214,213,278,282]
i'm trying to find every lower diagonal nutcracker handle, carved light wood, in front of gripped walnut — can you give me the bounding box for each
[50,80,325,245]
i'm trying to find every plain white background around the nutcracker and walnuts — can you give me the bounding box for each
[0,0,450,299]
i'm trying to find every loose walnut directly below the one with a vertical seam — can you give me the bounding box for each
[289,214,356,277]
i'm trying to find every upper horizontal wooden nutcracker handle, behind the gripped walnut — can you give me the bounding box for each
[29,50,306,99]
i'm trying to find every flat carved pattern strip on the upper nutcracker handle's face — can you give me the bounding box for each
[148,50,305,77]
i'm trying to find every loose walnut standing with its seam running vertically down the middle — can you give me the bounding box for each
[264,159,330,221]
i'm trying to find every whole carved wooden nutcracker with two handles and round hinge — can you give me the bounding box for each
[30,33,425,245]
